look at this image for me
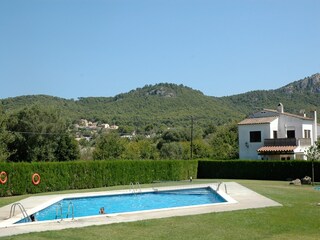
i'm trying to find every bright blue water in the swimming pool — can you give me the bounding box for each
[20,187,226,222]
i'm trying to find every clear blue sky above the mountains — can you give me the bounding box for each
[0,0,320,99]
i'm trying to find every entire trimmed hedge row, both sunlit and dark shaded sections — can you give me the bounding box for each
[0,160,320,197]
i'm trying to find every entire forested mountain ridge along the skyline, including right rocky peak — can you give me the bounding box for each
[0,73,320,128]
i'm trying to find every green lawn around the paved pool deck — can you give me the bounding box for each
[0,180,320,240]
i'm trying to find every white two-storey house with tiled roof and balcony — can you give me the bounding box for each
[238,103,320,160]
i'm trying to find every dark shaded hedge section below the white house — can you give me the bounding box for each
[197,160,320,181]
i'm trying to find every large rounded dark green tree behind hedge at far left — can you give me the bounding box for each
[8,105,79,162]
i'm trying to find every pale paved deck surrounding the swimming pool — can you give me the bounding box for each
[0,182,282,237]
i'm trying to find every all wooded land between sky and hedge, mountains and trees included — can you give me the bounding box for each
[0,74,320,162]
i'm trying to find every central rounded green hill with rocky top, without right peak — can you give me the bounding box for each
[1,84,245,130]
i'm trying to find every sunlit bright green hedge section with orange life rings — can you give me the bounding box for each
[0,160,198,196]
